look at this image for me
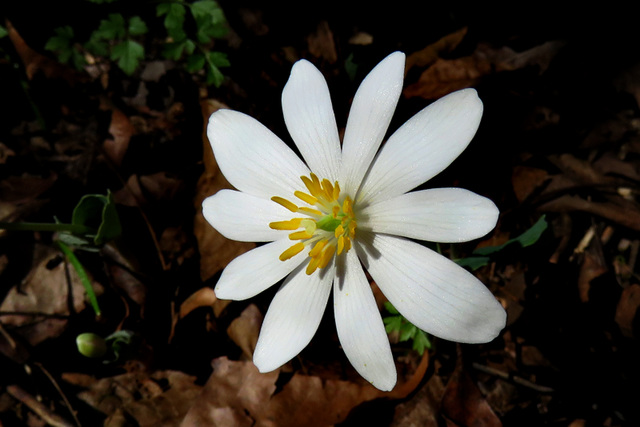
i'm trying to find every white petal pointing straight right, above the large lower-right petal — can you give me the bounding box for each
[358,188,500,243]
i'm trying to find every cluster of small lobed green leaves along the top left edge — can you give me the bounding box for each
[45,0,230,86]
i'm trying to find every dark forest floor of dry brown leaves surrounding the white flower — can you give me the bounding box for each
[0,1,640,427]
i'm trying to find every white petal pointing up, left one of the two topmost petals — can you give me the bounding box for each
[282,60,341,182]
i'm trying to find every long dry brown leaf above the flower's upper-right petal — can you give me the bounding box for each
[404,42,563,99]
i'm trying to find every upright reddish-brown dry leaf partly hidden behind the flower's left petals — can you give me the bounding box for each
[193,100,255,280]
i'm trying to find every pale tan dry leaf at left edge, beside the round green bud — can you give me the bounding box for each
[0,247,102,345]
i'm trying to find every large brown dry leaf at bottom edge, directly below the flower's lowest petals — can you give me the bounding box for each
[182,357,386,427]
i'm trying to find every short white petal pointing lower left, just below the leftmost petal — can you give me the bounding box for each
[215,238,308,301]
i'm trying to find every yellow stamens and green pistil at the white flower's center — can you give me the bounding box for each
[269,173,356,274]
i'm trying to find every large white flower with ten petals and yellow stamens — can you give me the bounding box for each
[203,52,506,390]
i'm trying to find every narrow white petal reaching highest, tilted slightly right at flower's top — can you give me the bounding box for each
[340,52,405,196]
